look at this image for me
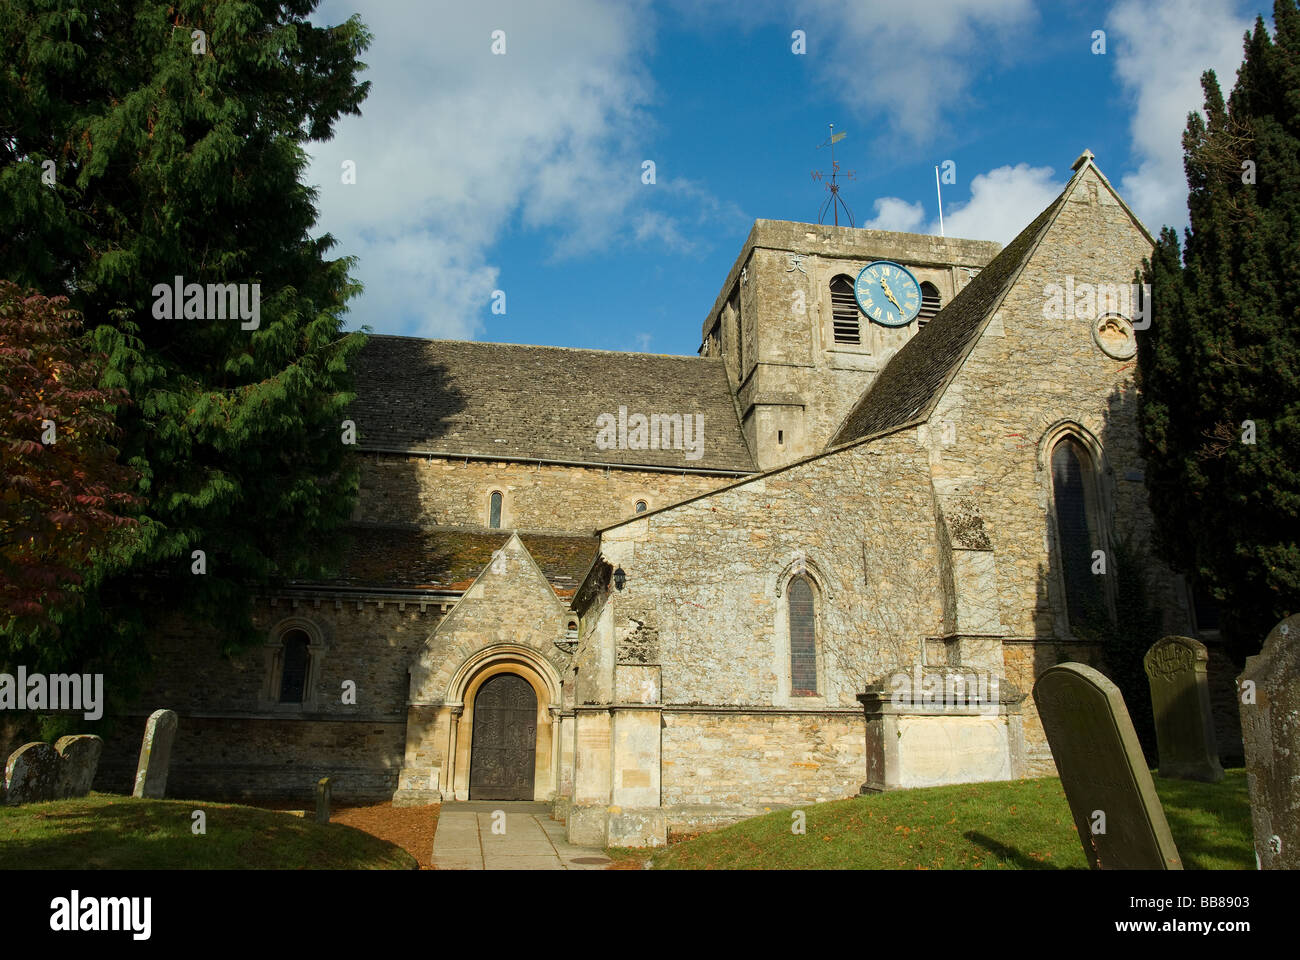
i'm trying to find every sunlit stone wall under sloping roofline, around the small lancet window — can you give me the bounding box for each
[590,431,943,710]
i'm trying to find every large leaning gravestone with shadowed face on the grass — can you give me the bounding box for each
[1034,663,1183,870]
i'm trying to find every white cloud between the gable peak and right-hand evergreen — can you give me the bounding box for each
[1106,0,1251,233]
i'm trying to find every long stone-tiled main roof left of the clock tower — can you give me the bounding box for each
[350,334,757,472]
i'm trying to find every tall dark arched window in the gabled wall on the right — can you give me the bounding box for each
[1052,437,1106,628]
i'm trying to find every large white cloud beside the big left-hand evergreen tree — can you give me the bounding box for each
[308,0,733,338]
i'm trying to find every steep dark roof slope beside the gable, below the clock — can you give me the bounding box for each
[827,180,1075,447]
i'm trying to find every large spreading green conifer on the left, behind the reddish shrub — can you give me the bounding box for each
[0,0,369,702]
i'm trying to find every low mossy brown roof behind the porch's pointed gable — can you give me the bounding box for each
[311,524,601,598]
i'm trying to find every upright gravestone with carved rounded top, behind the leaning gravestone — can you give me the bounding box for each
[1143,636,1223,783]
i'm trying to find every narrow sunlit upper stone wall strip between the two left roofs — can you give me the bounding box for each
[355,450,735,533]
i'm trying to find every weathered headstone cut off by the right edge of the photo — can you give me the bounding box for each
[1236,614,1300,870]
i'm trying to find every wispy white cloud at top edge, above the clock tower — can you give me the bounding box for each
[792,0,1037,143]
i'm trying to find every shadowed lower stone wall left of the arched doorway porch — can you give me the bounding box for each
[95,594,447,800]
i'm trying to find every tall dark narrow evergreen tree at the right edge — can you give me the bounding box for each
[1138,0,1300,658]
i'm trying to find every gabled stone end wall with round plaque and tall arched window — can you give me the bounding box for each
[922,164,1188,754]
